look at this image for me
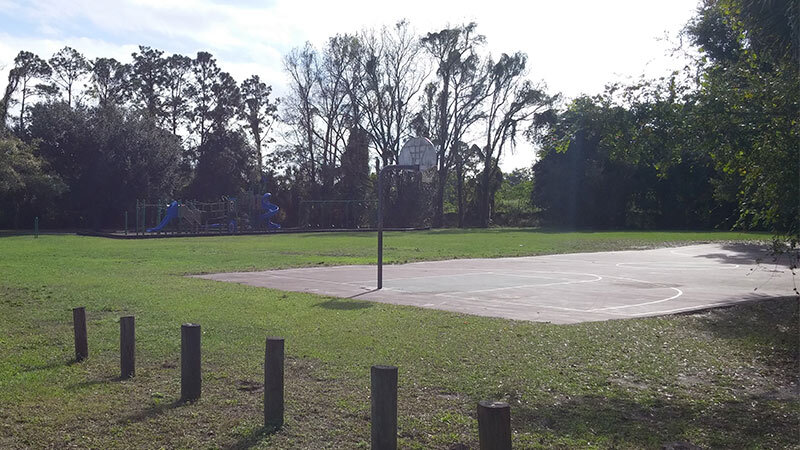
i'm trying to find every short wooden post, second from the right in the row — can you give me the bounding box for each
[370,366,397,450]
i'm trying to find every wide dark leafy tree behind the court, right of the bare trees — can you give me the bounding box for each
[532,81,732,229]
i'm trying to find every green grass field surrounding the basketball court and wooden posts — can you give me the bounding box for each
[0,230,800,448]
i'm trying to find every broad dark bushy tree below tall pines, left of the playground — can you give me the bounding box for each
[29,102,181,228]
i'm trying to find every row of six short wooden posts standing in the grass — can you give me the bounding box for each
[72,307,511,450]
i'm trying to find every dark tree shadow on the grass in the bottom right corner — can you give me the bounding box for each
[506,297,800,448]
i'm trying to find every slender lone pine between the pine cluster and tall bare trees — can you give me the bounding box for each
[239,75,278,187]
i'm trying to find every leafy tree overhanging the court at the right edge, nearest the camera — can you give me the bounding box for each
[687,0,800,239]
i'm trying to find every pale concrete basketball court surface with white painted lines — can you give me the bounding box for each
[197,244,800,324]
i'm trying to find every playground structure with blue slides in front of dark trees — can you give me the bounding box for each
[136,194,280,235]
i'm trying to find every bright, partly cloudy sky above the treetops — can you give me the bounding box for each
[0,0,698,170]
